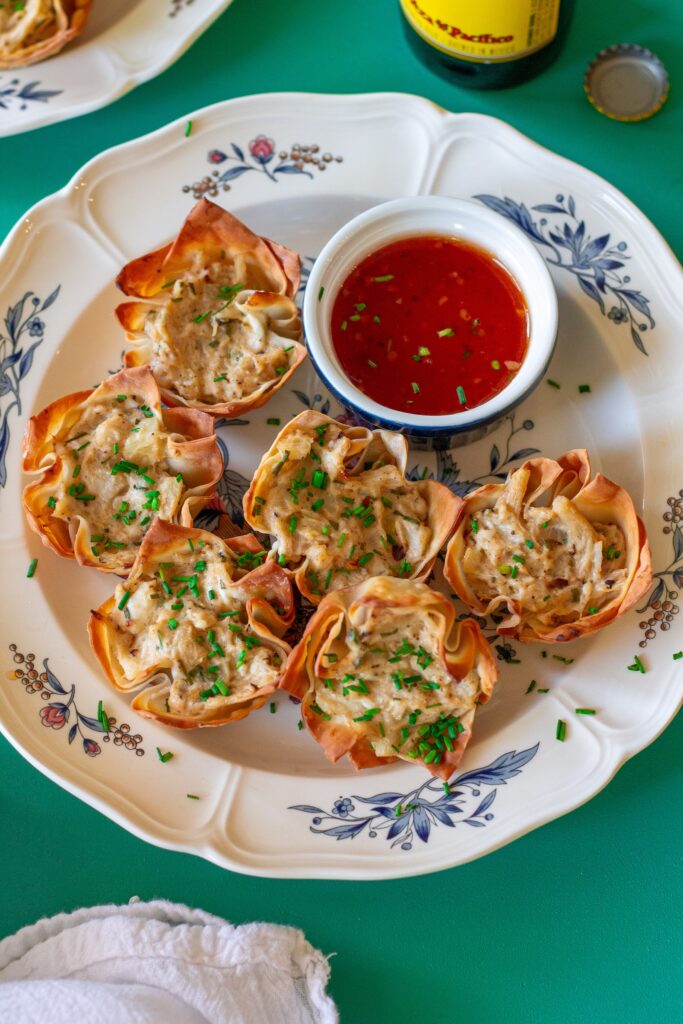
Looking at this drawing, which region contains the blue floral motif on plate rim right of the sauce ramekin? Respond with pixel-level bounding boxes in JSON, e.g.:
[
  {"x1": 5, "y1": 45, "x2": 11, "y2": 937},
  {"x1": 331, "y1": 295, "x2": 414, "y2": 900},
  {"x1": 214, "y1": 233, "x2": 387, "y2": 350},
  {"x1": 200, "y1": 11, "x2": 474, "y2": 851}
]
[{"x1": 474, "y1": 195, "x2": 654, "y2": 355}]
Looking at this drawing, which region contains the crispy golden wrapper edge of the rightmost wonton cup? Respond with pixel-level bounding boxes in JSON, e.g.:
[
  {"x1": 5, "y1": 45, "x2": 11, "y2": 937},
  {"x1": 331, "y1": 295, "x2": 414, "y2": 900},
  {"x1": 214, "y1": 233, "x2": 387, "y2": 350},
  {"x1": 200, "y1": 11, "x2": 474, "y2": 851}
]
[{"x1": 443, "y1": 449, "x2": 652, "y2": 643}]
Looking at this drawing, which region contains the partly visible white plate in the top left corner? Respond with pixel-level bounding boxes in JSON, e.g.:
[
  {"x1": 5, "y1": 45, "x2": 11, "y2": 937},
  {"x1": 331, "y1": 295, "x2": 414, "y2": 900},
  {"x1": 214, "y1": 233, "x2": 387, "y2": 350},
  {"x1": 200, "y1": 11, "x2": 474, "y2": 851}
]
[{"x1": 0, "y1": 0, "x2": 232, "y2": 137}]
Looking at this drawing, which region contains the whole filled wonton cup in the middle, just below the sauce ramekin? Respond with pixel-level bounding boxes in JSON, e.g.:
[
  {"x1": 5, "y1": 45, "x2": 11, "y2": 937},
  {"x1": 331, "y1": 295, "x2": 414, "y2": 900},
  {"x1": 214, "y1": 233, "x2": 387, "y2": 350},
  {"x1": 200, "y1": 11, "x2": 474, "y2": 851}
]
[{"x1": 244, "y1": 410, "x2": 462, "y2": 604}]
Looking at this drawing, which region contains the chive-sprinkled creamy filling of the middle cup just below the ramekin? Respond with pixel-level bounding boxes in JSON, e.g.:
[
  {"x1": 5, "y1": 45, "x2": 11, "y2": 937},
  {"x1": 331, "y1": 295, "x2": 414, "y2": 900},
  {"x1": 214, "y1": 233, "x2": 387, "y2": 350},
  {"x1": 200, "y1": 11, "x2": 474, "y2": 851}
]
[{"x1": 254, "y1": 424, "x2": 432, "y2": 594}]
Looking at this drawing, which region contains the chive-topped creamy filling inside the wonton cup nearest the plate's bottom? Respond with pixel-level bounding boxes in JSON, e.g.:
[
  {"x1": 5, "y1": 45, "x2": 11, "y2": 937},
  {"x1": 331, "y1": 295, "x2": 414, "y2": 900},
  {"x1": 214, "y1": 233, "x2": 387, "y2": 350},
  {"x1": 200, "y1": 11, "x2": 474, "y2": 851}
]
[{"x1": 312, "y1": 609, "x2": 480, "y2": 764}]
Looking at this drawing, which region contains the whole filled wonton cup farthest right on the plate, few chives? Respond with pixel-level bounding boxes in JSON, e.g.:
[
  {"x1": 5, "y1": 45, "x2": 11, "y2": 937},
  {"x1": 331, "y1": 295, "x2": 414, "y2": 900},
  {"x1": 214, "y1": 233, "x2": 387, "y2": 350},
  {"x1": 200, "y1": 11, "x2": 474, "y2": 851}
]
[{"x1": 444, "y1": 449, "x2": 652, "y2": 643}]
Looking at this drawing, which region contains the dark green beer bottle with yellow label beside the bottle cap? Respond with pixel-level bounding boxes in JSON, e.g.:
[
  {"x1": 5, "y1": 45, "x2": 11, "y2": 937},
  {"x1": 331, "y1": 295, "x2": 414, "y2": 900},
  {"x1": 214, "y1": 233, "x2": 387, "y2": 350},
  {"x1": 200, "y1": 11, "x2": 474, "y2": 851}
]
[{"x1": 399, "y1": 0, "x2": 574, "y2": 89}]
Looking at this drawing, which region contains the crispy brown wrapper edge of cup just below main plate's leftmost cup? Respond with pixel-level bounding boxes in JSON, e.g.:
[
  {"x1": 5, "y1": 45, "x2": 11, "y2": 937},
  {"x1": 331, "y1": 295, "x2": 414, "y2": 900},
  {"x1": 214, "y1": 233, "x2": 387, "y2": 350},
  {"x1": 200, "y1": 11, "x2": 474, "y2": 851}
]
[{"x1": 88, "y1": 519, "x2": 295, "y2": 729}]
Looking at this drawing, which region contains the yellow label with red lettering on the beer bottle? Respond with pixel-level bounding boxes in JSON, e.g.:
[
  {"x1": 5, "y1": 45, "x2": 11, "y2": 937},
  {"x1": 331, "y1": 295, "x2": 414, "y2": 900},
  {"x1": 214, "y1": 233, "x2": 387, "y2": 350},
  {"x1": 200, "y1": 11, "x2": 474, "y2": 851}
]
[{"x1": 400, "y1": 0, "x2": 560, "y2": 61}]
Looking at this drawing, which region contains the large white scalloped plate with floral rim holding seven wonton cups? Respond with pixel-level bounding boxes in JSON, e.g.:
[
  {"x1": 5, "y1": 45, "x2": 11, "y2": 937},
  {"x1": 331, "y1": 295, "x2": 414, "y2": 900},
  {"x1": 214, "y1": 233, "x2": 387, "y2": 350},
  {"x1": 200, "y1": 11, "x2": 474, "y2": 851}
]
[{"x1": 0, "y1": 94, "x2": 683, "y2": 879}]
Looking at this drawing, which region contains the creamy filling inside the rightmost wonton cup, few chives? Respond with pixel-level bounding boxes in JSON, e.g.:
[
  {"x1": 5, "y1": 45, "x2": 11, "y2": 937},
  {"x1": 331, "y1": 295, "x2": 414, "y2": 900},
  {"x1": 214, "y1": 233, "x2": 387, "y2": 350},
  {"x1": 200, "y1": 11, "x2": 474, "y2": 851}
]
[{"x1": 463, "y1": 493, "x2": 626, "y2": 626}]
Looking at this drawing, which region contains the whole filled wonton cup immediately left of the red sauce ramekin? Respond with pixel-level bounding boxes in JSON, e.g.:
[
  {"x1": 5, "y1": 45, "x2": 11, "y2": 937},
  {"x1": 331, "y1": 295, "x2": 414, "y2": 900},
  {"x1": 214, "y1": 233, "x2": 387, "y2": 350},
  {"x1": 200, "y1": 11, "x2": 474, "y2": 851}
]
[{"x1": 117, "y1": 199, "x2": 306, "y2": 418}]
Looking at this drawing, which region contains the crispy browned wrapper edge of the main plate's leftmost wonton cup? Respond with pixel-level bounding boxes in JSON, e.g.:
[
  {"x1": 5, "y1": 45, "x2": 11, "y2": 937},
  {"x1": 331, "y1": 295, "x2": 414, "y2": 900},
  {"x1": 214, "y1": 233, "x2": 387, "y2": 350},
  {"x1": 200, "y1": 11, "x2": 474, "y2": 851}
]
[{"x1": 22, "y1": 367, "x2": 223, "y2": 572}]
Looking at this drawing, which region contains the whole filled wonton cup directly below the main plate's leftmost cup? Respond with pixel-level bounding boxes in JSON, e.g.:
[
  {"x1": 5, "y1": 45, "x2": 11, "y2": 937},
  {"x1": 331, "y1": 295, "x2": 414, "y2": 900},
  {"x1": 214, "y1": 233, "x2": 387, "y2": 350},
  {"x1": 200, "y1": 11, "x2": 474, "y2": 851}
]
[{"x1": 88, "y1": 519, "x2": 294, "y2": 729}]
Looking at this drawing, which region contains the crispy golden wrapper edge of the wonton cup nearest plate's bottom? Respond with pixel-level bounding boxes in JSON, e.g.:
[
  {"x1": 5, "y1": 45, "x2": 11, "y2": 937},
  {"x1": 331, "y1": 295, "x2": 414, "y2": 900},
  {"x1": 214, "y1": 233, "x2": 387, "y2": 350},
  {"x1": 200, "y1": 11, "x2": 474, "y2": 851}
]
[{"x1": 279, "y1": 577, "x2": 498, "y2": 779}]
